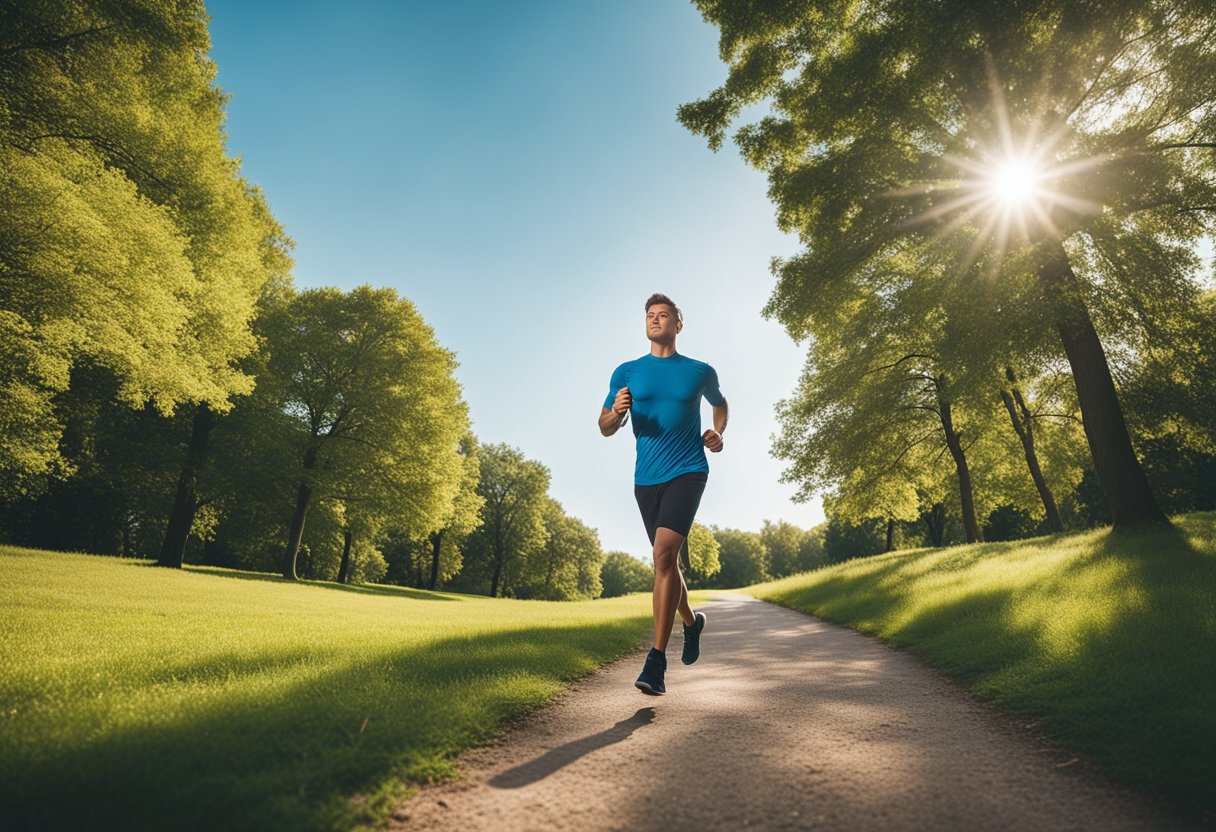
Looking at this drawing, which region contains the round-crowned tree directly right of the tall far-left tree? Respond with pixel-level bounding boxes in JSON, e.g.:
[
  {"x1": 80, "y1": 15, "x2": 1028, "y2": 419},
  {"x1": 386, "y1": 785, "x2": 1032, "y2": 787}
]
[{"x1": 266, "y1": 286, "x2": 468, "y2": 579}]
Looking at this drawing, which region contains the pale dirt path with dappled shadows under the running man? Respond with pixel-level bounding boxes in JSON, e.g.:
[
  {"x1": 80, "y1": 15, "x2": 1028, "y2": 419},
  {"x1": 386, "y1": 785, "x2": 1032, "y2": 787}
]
[{"x1": 394, "y1": 596, "x2": 1187, "y2": 832}]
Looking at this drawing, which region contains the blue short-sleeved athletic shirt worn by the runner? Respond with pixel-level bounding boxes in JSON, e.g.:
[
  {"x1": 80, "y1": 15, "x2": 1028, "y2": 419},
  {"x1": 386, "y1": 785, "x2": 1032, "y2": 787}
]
[{"x1": 604, "y1": 353, "x2": 726, "y2": 485}]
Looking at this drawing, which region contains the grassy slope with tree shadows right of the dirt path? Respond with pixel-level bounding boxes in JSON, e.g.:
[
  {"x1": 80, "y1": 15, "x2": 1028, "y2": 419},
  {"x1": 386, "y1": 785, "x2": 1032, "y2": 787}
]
[{"x1": 749, "y1": 513, "x2": 1216, "y2": 814}]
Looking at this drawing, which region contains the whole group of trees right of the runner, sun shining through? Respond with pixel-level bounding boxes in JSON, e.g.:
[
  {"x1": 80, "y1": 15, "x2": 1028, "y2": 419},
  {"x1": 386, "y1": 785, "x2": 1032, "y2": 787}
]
[{"x1": 680, "y1": 0, "x2": 1216, "y2": 542}]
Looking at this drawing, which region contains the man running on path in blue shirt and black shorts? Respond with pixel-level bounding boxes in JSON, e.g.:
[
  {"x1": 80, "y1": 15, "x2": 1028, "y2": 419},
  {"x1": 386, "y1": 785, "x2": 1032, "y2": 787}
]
[{"x1": 599, "y1": 294, "x2": 727, "y2": 696}]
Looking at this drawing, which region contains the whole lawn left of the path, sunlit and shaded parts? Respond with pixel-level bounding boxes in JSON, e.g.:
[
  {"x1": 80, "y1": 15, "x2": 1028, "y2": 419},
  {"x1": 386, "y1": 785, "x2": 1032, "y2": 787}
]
[{"x1": 0, "y1": 547, "x2": 651, "y2": 831}]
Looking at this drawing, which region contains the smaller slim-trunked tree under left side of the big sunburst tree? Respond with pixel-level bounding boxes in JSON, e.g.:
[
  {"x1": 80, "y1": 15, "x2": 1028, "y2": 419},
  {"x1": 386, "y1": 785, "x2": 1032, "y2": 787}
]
[{"x1": 773, "y1": 285, "x2": 983, "y2": 541}]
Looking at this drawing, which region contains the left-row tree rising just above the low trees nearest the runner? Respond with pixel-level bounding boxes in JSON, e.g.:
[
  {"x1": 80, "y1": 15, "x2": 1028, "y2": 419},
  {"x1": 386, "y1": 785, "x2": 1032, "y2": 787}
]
[{"x1": 461, "y1": 444, "x2": 548, "y2": 597}]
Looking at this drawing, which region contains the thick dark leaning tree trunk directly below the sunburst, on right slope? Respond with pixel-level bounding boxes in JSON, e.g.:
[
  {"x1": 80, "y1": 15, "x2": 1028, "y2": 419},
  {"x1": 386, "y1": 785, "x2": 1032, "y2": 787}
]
[{"x1": 1038, "y1": 243, "x2": 1169, "y2": 532}]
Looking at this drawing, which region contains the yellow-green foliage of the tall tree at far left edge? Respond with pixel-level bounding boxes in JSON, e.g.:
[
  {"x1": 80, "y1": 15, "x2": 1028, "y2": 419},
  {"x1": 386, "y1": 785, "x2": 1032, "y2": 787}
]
[{"x1": 0, "y1": 0, "x2": 289, "y2": 486}]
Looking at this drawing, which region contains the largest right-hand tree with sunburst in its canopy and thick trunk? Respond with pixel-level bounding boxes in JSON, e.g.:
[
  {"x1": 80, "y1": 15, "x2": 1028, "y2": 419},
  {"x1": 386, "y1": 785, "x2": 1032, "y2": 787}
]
[{"x1": 680, "y1": 0, "x2": 1216, "y2": 529}]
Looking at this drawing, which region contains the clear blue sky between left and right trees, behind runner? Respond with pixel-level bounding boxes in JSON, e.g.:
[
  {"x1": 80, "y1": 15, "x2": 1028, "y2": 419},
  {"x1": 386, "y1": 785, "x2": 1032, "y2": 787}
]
[{"x1": 208, "y1": 0, "x2": 822, "y2": 557}]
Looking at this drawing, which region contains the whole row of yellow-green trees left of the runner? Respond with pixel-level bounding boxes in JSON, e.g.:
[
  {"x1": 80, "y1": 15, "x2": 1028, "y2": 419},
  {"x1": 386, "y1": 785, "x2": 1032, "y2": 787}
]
[{"x1": 0, "y1": 0, "x2": 603, "y2": 598}]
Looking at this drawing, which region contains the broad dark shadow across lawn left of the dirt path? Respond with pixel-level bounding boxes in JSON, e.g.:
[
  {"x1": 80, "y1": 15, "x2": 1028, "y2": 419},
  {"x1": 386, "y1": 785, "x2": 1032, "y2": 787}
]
[{"x1": 0, "y1": 617, "x2": 648, "y2": 831}]
